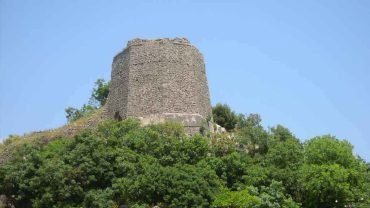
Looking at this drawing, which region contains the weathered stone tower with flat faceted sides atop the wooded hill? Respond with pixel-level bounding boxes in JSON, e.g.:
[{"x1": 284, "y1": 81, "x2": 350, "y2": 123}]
[{"x1": 108, "y1": 38, "x2": 212, "y2": 134}]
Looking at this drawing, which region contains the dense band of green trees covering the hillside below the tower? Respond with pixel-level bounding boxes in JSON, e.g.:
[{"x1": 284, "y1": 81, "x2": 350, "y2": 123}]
[{"x1": 0, "y1": 114, "x2": 370, "y2": 208}]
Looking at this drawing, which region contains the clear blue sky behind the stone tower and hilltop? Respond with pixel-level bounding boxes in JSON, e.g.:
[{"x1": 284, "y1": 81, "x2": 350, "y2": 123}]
[{"x1": 0, "y1": 0, "x2": 370, "y2": 161}]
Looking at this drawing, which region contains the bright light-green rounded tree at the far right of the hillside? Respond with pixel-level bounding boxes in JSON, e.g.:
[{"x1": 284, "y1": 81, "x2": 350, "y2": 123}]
[{"x1": 298, "y1": 135, "x2": 369, "y2": 207}]
